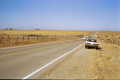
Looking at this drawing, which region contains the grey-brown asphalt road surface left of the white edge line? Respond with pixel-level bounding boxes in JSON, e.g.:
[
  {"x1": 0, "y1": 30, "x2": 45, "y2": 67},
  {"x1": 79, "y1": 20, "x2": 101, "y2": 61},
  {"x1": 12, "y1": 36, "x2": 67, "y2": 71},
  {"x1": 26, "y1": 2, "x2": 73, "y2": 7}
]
[{"x1": 0, "y1": 40, "x2": 81, "y2": 79}]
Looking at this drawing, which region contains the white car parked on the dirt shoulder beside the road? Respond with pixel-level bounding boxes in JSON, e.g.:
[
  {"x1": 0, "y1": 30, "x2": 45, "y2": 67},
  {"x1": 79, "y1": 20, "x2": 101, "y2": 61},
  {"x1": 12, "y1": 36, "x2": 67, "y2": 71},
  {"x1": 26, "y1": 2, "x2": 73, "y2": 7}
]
[{"x1": 85, "y1": 39, "x2": 99, "y2": 49}]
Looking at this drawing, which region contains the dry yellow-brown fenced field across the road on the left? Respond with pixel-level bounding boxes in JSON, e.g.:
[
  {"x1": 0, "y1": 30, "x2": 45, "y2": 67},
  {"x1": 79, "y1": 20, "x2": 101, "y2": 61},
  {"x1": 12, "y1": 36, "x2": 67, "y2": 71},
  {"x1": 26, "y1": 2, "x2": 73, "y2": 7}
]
[{"x1": 0, "y1": 30, "x2": 91, "y2": 47}]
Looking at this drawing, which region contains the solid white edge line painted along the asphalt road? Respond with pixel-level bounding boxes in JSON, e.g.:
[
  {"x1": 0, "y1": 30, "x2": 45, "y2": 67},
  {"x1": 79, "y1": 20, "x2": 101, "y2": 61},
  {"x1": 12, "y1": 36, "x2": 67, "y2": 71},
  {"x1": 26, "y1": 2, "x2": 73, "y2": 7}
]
[{"x1": 22, "y1": 44, "x2": 80, "y2": 79}]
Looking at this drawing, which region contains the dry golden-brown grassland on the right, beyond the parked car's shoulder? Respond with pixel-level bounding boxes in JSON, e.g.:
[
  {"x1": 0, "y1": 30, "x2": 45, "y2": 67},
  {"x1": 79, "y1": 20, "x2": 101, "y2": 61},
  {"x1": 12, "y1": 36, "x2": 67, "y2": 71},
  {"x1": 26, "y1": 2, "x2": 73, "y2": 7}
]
[{"x1": 94, "y1": 31, "x2": 120, "y2": 80}]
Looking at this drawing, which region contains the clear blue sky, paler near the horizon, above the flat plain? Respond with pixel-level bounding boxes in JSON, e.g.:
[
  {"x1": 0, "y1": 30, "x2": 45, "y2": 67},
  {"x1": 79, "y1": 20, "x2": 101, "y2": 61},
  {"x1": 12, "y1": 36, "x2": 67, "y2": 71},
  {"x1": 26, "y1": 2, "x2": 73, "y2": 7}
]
[{"x1": 0, "y1": 0, "x2": 120, "y2": 30}]
